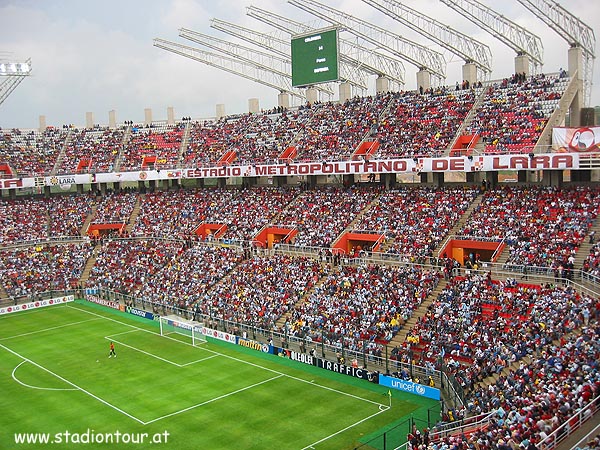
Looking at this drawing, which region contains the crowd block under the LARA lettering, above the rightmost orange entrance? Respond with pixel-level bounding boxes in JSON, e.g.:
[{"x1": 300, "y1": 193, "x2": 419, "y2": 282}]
[{"x1": 460, "y1": 186, "x2": 600, "y2": 270}]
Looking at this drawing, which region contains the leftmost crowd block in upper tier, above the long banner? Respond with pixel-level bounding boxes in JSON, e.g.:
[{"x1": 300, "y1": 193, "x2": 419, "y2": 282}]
[{"x1": 0, "y1": 127, "x2": 67, "y2": 177}]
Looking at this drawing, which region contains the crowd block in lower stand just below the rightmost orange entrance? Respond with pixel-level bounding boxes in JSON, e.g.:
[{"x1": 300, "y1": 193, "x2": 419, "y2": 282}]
[{"x1": 403, "y1": 273, "x2": 600, "y2": 392}]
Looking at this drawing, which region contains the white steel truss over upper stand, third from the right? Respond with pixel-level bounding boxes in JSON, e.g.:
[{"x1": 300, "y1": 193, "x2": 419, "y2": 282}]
[{"x1": 363, "y1": 0, "x2": 492, "y2": 79}]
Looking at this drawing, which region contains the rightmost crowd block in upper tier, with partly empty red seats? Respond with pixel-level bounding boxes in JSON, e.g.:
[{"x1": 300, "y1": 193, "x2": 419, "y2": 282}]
[{"x1": 465, "y1": 74, "x2": 568, "y2": 153}]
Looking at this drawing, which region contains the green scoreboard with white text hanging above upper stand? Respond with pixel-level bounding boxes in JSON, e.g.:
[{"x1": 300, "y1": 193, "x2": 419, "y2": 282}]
[{"x1": 292, "y1": 28, "x2": 339, "y2": 87}]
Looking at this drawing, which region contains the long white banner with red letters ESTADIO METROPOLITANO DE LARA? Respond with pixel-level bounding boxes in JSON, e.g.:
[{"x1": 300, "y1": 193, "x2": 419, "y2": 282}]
[{"x1": 0, "y1": 154, "x2": 584, "y2": 190}]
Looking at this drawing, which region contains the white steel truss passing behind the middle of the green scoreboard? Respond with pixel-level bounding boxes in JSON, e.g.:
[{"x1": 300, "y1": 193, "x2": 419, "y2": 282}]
[{"x1": 210, "y1": 19, "x2": 368, "y2": 92}]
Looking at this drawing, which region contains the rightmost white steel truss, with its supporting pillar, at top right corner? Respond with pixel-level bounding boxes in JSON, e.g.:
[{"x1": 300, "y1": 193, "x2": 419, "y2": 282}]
[{"x1": 517, "y1": 0, "x2": 596, "y2": 105}]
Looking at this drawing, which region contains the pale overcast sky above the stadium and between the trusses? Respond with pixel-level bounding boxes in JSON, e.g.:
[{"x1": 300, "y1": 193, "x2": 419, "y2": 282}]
[{"x1": 0, "y1": 0, "x2": 600, "y2": 129}]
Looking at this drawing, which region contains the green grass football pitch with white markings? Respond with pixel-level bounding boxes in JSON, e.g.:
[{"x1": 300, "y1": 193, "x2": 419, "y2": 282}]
[{"x1": 0, "y1": 302, "x2": 438, "y2": 450}]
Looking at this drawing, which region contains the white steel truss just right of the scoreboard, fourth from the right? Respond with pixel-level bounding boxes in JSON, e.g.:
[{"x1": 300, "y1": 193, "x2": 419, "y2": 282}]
[{"x1": 288, "y1": 0, "x2": 446, "y2": 84}]
